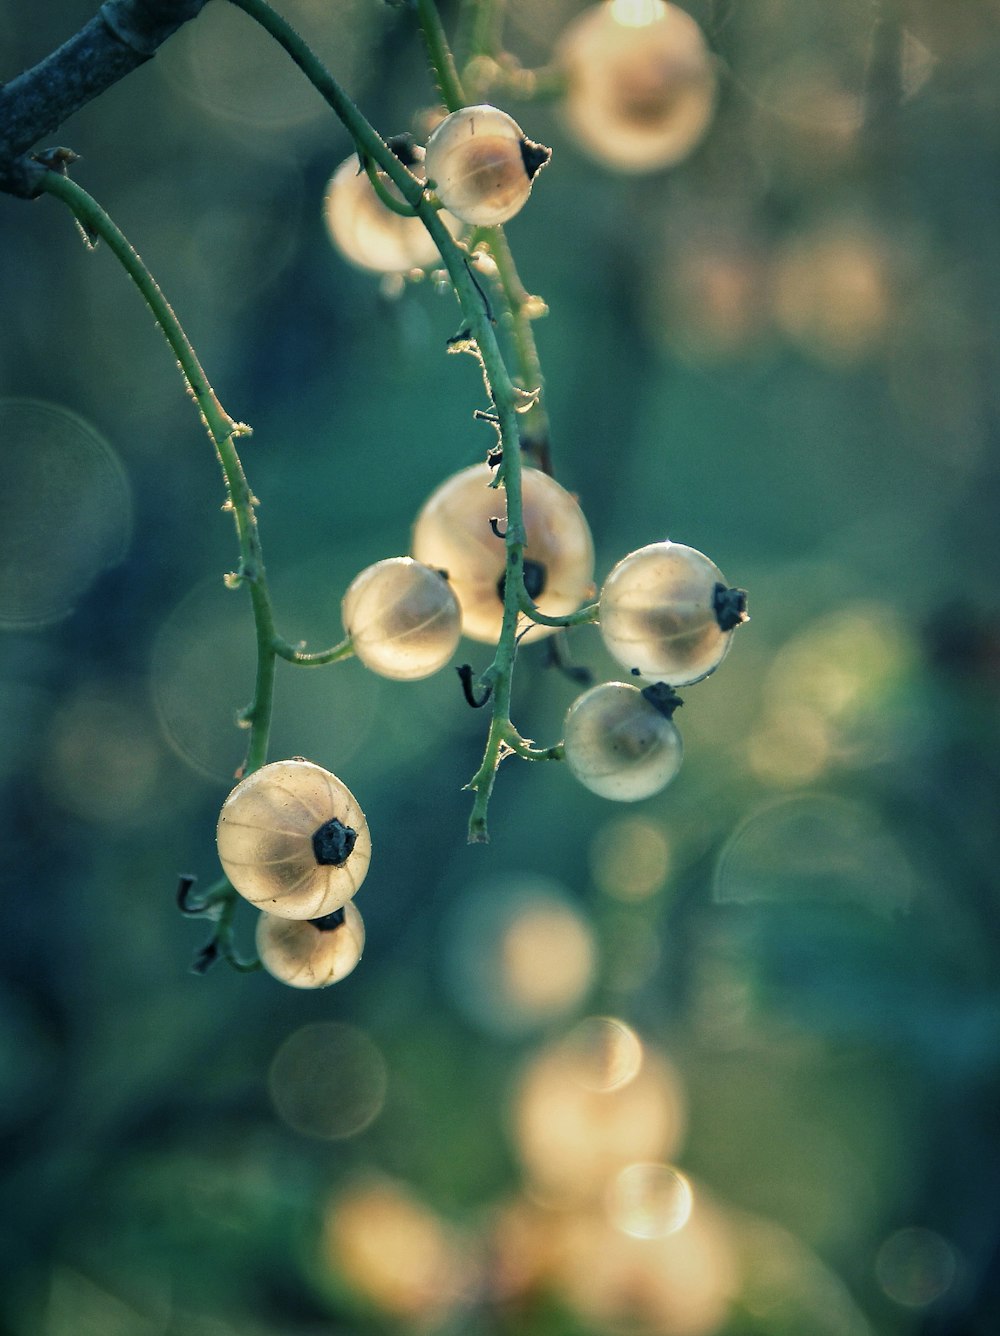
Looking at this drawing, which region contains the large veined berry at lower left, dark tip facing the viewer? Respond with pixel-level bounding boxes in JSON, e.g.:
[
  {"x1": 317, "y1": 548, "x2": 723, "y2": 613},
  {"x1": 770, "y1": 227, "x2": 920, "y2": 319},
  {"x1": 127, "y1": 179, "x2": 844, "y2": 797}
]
[{"x1": 216, "y1": 758, "x2": 371, "y2": 919}]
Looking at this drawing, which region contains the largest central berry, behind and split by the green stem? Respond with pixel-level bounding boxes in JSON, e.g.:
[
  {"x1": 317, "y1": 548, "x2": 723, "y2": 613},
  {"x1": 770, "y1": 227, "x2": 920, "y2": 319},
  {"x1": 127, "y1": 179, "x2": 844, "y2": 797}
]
[{"x1": 413, "y1": 464, "x2": 594, "y2": 644}]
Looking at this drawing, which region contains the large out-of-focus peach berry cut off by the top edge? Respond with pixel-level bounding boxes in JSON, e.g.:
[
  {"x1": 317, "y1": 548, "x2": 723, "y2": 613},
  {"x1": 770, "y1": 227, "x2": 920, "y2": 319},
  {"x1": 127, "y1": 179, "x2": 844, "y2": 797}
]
[{"x1": 557, "y1": 0, "x2": 716, "y2": 172}]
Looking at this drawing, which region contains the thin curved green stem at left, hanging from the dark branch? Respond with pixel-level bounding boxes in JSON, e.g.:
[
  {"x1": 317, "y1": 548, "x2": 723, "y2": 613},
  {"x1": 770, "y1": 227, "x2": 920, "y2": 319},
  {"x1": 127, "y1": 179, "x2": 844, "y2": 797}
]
[{"x1": 43, "y1": 171, "x2": 275, "y2": 774}]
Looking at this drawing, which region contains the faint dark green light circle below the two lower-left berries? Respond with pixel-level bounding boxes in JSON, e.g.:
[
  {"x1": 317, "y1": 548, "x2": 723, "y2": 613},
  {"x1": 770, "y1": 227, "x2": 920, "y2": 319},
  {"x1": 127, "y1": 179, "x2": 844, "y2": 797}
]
[{"x1": 267, "y1": 1022, "x2": 387, "y2": 1141}]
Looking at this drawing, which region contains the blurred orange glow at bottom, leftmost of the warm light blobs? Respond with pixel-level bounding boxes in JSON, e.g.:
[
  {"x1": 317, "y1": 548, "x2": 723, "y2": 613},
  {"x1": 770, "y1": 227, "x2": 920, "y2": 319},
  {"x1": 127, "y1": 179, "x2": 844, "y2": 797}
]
[{"x1": 322, "y1": 1178, "x2": 475, "y2": 1324}]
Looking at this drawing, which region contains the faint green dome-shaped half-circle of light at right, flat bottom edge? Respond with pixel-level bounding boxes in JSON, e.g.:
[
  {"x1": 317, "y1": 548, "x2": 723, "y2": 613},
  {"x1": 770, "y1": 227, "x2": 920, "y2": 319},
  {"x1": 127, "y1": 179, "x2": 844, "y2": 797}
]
[{"x1": 714, "y1": 794, "x2": 915, "y2": 915}]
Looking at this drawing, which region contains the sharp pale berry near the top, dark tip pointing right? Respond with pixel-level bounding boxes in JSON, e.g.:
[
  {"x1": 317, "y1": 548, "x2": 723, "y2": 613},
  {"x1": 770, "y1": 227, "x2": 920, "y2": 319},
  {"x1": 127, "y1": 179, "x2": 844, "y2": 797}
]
[{"x1": 425, "y1": 106, "x2": 550, "y2": 227}]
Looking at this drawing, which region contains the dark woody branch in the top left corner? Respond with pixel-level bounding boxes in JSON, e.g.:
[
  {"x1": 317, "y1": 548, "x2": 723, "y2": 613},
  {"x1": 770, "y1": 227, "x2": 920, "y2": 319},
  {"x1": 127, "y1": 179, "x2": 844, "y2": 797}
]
[{"x1": 0, "y1": 0, "x2": 207, "y2": 199}]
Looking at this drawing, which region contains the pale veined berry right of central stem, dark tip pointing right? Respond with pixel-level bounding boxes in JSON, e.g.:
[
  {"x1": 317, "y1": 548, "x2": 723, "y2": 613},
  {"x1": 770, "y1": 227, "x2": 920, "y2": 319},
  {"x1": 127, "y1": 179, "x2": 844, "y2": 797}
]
[{"x1": 598, "y1": 541, "x2": 746, "y2": 687}]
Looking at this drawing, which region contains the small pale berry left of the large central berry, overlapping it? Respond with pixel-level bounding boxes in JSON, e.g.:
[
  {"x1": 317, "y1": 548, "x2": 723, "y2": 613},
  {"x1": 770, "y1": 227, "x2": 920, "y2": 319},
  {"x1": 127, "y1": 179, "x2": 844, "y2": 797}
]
[{"x1": 340, "y1": 557, "x2": 462, "y2": 681}]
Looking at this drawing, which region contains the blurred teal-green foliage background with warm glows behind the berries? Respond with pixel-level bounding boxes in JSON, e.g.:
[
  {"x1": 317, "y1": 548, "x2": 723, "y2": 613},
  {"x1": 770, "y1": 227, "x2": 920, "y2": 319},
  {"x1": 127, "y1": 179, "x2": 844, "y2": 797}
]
[{"x1": 0, "y1": 0, "x2": 1000, "y2": 1336}]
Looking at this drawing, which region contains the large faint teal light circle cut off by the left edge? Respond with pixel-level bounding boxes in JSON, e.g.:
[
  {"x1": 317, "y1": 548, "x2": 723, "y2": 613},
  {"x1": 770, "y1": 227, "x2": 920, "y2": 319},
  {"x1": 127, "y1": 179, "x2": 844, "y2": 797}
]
[{"x1": 0, "y1": 399, "x2": 132, "y2": 628}]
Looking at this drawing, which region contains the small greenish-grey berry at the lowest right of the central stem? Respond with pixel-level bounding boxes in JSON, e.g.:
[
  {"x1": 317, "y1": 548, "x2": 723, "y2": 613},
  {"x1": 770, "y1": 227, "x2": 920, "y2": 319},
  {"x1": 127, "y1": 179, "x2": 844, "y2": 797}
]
[{"x1": 565, "y1": 681, "x2": 684, "y2": 803}]
